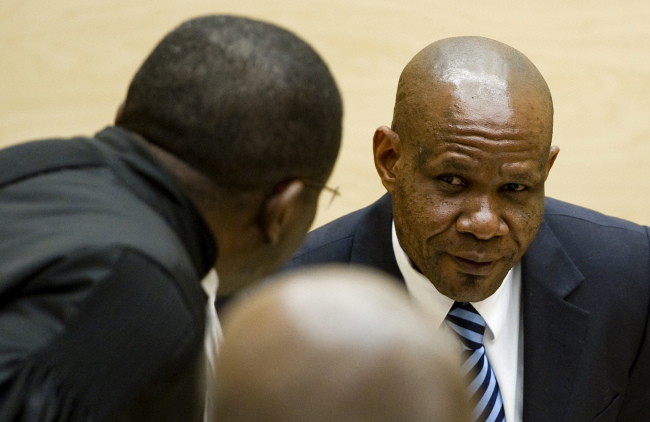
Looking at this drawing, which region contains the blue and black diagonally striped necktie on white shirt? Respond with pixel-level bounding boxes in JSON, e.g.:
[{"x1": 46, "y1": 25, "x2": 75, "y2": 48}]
[{"x1": 446, "y1": 302, "x2": 506, "y2": 422}]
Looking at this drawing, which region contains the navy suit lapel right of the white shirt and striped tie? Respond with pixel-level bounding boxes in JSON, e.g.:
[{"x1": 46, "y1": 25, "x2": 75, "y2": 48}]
[{"x1": 522, "y1": 222, "x2": 590, "y2": 422}]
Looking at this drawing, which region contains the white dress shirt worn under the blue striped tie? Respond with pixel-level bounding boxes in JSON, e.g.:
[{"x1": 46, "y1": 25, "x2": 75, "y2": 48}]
[{"x1": 393, "y1": 223, "x2": 524, "y2": 422}]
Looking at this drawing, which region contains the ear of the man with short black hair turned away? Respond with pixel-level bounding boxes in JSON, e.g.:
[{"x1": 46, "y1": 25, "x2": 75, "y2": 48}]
[{"x1": 260, "y1": 180, "x2": 305, "y2": 245}]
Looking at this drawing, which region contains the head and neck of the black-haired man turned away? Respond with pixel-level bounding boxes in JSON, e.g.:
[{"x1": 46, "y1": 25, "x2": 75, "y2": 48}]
[{"x1": 116, "y1": 16, "x2": 342, "y2": 290}]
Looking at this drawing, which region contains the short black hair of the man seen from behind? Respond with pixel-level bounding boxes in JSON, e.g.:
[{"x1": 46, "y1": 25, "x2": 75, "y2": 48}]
[{"x1": 117, "y1": 15, "x2": 343, "y2": 191}]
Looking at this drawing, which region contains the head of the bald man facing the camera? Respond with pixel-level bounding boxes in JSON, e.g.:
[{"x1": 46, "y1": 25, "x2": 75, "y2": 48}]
[{"x1": 374, "y1": 37, "x2": 559, "y2": 302}]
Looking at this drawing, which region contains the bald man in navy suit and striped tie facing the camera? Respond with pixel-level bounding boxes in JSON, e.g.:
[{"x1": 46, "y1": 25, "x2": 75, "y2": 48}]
[{"x1": 287, "y1": 37, "x2": 650, "y2": 422}]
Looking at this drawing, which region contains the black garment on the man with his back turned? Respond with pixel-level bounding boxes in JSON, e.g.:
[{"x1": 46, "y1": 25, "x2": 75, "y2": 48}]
[{"x1": 0, "y1": 127, "x2": 216, "y2": 421}]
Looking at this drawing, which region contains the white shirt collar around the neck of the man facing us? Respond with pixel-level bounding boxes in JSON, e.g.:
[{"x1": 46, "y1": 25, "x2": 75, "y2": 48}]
[{"x1": 392, "y1": 221, "x2": 521, "y2": 340}]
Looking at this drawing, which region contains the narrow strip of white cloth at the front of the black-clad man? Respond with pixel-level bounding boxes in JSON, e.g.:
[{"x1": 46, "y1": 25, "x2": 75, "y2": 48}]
[{"x1": 201, "y1": 269, "x2": 223, "y2": 422}]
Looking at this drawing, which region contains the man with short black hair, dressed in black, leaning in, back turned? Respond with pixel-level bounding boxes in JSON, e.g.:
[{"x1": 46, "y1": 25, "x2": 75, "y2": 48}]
[{"x1": 0, "y1": 16, "x2": 342, "y2": 421}]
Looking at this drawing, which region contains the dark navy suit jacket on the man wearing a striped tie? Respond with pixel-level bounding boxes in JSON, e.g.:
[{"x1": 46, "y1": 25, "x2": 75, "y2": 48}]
[{"x1": 285, "y1": 195, "x2": 650, "y2": 422}]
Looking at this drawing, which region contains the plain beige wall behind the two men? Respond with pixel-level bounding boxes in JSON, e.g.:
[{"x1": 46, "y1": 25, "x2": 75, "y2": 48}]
[{"x1": 0, "y1": 0, "x2": 650, "y2": 225}]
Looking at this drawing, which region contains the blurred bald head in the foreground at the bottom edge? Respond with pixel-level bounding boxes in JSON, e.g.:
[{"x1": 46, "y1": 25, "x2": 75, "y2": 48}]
[{"x1": 217, "y1": 266, "x2": 468, "y2": 422}]
